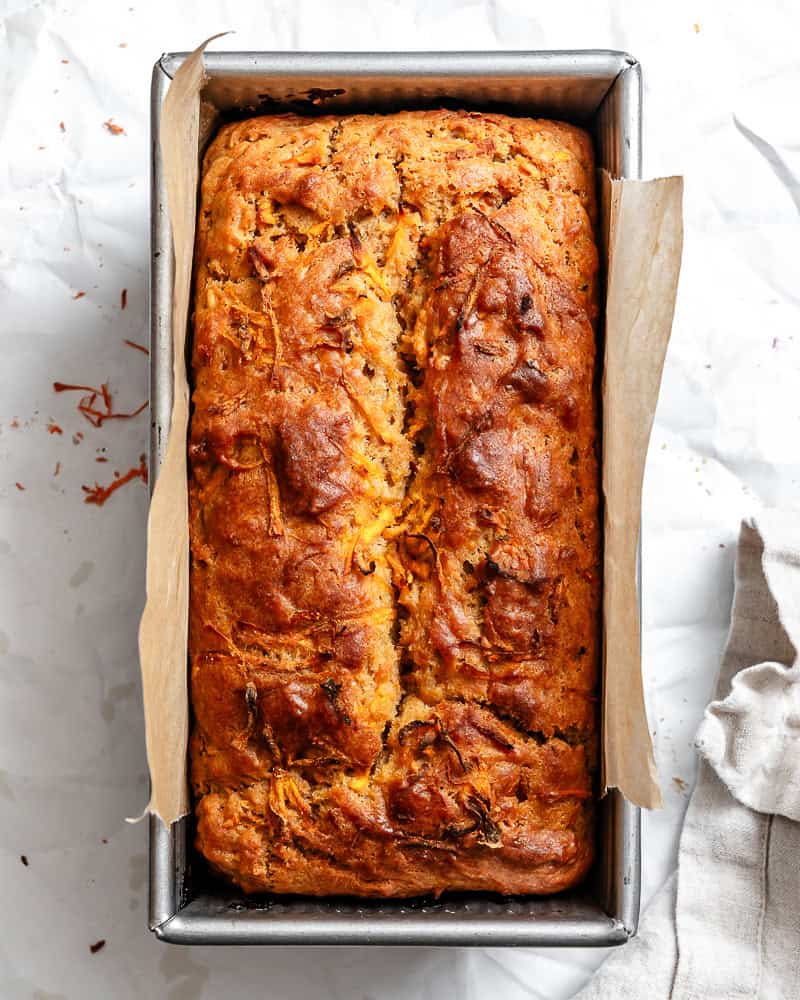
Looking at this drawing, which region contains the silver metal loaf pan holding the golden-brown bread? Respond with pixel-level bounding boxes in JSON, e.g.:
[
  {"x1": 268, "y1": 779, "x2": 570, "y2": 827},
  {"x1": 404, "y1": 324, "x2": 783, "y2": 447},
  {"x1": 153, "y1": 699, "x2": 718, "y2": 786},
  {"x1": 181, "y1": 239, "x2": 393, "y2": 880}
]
[{"x1": 149, "y1": 51, "x2": 641, "y2": 947}]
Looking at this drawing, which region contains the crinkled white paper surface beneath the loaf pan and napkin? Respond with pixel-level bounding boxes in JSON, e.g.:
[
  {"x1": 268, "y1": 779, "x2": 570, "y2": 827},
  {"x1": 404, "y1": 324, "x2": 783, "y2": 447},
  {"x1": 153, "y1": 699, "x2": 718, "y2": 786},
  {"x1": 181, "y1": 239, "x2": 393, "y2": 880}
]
[{"x1": 0, "y1": 0, "x2": 800, "y2": 1000}]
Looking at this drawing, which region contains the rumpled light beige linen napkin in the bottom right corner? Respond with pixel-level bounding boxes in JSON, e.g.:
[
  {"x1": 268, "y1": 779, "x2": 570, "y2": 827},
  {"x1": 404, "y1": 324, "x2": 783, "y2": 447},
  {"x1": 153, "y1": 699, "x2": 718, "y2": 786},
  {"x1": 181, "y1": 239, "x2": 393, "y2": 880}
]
[{"x1": 576, "y1": 511, "x2": 800, "y2": 1000}]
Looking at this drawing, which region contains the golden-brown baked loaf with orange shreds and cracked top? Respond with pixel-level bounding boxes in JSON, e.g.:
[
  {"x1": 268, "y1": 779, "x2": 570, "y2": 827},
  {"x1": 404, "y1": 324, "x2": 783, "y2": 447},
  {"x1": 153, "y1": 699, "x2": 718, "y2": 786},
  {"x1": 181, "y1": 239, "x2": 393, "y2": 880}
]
[{"x1": 189, "y1": 111, "x2": 600, "y2": 896}]
